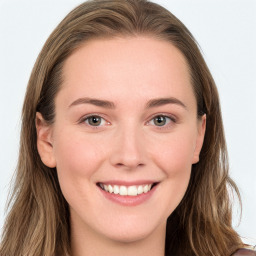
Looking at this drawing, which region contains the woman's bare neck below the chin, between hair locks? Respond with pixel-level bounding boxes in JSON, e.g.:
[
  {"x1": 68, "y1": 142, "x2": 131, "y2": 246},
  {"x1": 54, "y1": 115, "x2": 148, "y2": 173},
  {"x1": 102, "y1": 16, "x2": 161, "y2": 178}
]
[{"x1": 71, "y1": 217, "x2": 166, "y2": 256}]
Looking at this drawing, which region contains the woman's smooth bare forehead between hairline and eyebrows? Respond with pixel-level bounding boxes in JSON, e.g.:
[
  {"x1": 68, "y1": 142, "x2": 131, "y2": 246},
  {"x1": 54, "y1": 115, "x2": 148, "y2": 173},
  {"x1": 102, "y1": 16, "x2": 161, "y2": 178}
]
[{"x1": 59, "y1": 36, "x2": 193, "y2": 107}]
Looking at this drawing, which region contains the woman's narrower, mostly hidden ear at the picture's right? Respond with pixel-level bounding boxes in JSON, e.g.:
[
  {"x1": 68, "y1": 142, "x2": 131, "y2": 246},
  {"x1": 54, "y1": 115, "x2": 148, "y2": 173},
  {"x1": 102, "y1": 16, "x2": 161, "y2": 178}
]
[{"x1": 192, "y1": 114, "x2": 206, "y2": 164}]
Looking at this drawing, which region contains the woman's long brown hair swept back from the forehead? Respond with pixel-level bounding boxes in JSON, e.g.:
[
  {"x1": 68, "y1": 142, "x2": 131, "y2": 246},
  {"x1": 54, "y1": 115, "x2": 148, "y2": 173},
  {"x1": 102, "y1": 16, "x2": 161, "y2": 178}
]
[{"x1": 0, "y1": 0, "x2": 242, "y2": 256}]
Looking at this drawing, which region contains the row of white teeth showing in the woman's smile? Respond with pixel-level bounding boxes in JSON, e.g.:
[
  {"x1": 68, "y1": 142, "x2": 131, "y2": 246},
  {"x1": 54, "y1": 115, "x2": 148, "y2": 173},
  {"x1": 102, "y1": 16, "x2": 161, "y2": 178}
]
[{"x1": 99, "y1": 183, "x2": 153, "y2": 196}]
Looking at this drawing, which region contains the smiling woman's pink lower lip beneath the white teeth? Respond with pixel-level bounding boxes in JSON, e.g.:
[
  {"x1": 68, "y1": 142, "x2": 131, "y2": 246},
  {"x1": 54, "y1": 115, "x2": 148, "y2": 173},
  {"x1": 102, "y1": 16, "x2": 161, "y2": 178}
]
[{"x1": 99, "y1": 185, "x2": 157, "y2": 206}]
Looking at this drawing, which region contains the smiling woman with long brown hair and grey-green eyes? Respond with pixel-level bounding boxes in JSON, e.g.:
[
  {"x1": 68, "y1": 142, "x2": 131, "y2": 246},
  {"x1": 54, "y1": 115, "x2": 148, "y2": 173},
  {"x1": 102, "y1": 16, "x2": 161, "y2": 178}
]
[{"x1": 0, "y1": 0, "x2": 255, "y2": 256}]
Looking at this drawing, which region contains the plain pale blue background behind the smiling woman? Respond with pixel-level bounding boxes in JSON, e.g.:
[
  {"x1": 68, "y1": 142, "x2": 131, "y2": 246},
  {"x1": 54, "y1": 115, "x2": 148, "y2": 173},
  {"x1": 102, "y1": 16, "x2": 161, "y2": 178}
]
[{"x1": 0, "y1": 0, "x2": 256, "y2": 244}]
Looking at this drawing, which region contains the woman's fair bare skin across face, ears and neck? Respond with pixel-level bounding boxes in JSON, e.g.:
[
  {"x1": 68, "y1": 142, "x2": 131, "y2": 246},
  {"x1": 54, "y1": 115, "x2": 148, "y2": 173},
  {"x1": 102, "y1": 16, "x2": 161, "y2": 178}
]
[{"x1": 36, "y1": 36, "x2": 206, "y2": 256}]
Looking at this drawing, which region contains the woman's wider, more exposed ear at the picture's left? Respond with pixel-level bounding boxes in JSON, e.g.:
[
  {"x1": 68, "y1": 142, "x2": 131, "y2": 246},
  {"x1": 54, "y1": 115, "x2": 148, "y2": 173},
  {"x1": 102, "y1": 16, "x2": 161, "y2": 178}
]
[{"x1": 35, "y1": 112, "x2": 56, "y2": 168}]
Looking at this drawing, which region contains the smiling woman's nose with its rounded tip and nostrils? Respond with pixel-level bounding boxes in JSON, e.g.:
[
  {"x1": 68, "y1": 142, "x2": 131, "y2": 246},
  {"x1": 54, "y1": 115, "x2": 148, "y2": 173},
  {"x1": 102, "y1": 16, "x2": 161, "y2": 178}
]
[{"x1": 110, "y1": 124, "x2": 146, "y2": 170}]
